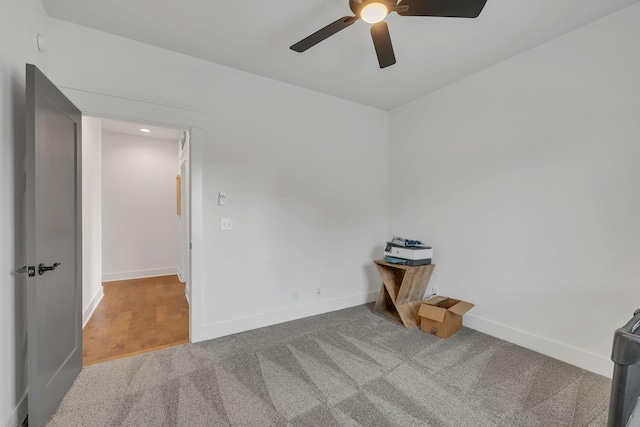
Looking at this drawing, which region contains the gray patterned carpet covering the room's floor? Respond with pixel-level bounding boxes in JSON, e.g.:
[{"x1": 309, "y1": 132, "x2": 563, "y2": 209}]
[{"x1": 48, "y1": 305, "x2": 611, "y2": 427}]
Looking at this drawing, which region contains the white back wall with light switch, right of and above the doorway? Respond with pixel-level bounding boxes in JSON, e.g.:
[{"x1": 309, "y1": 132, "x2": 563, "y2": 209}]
[{"x1": 50, "y1": 19, "x2": 388, "y2": 341}]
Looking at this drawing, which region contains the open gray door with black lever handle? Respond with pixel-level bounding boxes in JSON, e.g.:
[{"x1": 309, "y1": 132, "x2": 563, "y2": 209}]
[{"x1": 26, "y1": 64, "x2": 82, "y2": 427}]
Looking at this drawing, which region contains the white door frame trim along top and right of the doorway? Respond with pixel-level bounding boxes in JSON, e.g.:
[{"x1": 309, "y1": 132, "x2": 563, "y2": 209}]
[{"x1": 59, "y1": 86, "x2": 205, "y2": 342}]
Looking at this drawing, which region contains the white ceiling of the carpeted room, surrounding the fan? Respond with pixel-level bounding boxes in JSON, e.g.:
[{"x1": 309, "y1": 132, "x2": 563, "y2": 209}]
[{"x1": 42, "y1": 0, "x2": 640, "y2": 110}]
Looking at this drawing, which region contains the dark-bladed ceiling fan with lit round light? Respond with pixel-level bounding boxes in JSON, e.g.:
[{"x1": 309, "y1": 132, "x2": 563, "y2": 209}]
[{"x1": 290, "y1": 0, "x2": 487, "y2": 68}]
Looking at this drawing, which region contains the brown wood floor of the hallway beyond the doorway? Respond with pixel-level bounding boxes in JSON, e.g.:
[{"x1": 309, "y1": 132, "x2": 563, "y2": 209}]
[{"x1": 82, "y1": 275, "x2": 189, "y2": 366}]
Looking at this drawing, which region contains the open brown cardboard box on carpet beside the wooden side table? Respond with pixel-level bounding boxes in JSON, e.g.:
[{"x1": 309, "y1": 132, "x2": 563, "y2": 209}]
[{"x1": 418, "y1": 296, "x2": 474, "y2": 338}]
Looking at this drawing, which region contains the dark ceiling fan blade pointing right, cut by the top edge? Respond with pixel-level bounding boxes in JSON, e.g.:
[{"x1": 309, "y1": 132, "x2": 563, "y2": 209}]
[{"x1": 398, "y1": 0, "x2": 487, "y2": 18}]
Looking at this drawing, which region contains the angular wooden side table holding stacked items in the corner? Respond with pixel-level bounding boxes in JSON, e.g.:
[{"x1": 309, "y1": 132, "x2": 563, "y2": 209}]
[{"x1": 373, "y1": 259, "x2": 435, "y2": 328}]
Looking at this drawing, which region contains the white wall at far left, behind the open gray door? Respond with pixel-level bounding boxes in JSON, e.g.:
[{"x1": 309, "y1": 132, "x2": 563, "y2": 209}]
[{"x1": 0, "y1": 0, "x2": 48, "y2": 427}]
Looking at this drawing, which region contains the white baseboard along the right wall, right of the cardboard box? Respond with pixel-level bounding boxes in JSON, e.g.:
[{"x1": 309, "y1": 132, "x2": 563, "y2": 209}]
[{"x1": 463, "y1": 314, "x2": 613, "y2": 378}]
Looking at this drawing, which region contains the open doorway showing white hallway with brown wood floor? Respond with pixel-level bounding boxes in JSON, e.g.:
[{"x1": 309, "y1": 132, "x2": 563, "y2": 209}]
[{"x1": 82, "y1": 116, "x2": 190, "y2": 365}]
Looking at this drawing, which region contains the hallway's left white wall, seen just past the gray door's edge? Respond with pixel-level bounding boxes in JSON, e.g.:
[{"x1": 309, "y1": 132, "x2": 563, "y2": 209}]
[{"x1": 82, "y1": 116, "x2": 104, "y2": 326}]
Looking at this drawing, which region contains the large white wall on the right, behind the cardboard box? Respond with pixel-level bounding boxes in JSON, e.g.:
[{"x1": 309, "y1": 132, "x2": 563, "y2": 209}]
[{"x1": 389, "y1": 5, "x2": 640, "y2": 375}]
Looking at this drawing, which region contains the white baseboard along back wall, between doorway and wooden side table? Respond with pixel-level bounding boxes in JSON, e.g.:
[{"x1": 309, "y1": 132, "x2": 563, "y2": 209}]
[{"x1": 191, "y1": 291, "x2": 379, "y2": 342}]
